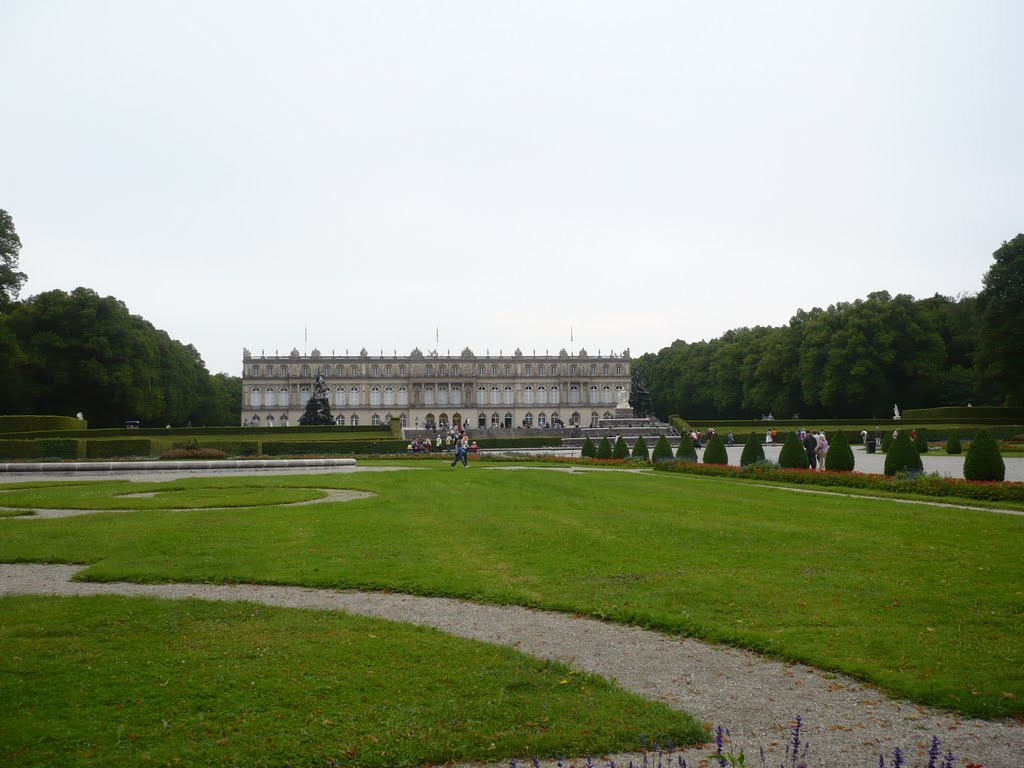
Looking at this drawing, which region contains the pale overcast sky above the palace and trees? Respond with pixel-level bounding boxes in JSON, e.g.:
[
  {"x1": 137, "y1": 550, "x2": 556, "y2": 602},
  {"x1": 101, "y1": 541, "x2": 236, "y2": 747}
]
[{"x1": 0, "y1": 0, "x2": 1024, "y2": 375}]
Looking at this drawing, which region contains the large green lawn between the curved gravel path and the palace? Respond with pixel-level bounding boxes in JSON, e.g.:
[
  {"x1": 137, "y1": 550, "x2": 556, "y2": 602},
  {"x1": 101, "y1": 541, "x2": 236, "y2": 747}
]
[{"x1": 0, "y1": 468, "x2": 1024, "y2": 717}]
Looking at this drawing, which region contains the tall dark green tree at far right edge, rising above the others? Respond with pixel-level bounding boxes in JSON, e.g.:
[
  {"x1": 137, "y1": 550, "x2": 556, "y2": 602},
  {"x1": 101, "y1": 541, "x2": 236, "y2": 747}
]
[{"x1": 977, "y1": 234, "x2": 1024, "y2": 406}]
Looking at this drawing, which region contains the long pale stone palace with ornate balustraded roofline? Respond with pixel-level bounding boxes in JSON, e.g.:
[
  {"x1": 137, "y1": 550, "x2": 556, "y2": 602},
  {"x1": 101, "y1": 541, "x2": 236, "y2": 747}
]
[{"x1": 242, "y1": 348, "x2": 631, "y2": 429}]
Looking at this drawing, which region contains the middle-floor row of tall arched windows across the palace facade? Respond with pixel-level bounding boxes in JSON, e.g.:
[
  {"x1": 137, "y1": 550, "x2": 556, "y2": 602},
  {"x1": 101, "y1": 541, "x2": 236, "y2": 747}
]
[{"x1": 249, "y1": 384, "x2": 623, "y2": 408}]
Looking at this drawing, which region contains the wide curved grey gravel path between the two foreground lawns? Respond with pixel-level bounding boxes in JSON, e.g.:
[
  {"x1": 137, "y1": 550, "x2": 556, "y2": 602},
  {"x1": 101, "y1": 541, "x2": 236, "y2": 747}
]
[{"x1": 0, "y1": 564, "x2": 1024, "y2": 768}]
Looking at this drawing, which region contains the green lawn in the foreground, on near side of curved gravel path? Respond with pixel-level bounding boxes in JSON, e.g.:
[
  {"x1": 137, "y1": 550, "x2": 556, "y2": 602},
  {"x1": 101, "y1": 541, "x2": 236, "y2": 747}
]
[{"x1": 0, "y1": 596, "x2": 707, "y2": 768}]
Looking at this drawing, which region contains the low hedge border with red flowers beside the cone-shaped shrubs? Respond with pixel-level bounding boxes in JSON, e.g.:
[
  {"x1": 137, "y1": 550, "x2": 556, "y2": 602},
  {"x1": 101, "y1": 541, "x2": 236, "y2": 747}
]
[{"x1": 654, "y1": 462, "x2": 1024, "y2": 504}]
